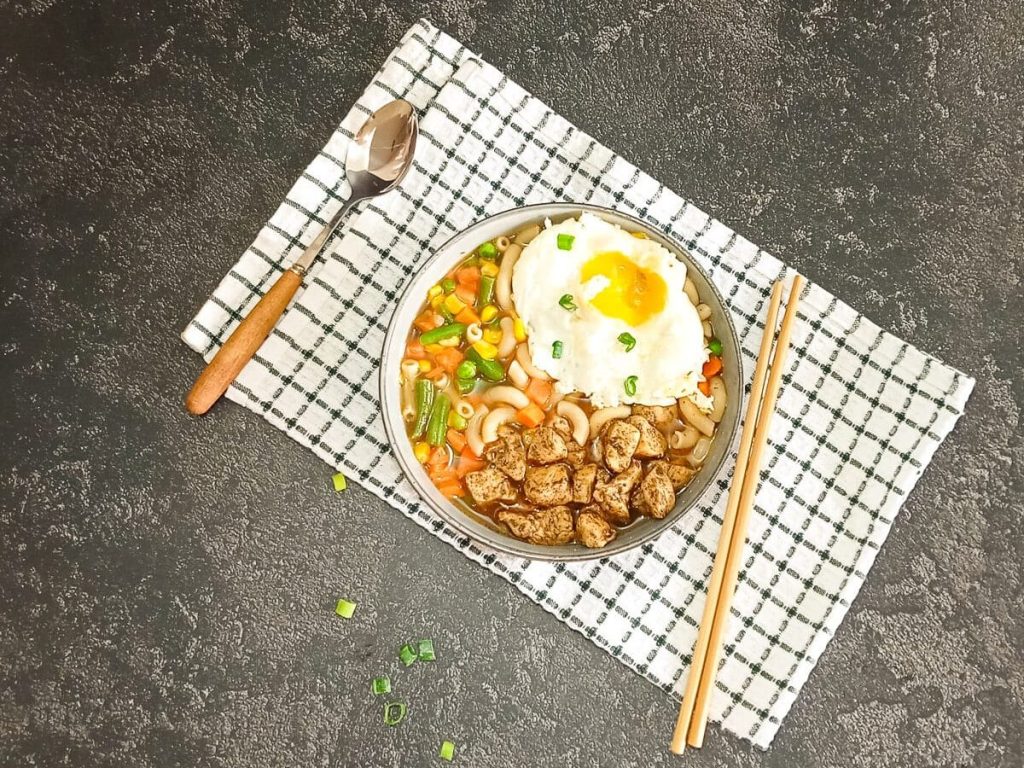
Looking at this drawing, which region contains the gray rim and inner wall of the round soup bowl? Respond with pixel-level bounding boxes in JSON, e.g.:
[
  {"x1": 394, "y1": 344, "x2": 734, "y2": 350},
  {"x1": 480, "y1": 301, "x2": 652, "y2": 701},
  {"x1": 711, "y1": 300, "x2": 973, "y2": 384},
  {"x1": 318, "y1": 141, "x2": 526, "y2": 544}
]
[{"x1": 379, "y1": 203, "x2": 745, "y2": 562}]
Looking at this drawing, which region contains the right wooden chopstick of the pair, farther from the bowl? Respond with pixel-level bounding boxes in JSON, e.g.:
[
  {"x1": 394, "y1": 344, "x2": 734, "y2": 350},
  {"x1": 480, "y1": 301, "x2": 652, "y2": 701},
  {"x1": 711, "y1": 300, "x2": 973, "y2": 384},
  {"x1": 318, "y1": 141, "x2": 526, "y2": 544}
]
[{"x1": 686, "y1": 274, "x2": 804, "y2": 748}]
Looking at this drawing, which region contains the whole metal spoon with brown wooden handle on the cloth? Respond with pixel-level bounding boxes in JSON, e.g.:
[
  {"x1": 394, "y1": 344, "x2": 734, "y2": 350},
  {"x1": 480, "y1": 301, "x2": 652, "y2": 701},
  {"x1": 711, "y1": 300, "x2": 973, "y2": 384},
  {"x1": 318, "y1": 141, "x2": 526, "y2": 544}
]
[{"x1": 185, "y1": 99, "x2": 418, "y2": 416}]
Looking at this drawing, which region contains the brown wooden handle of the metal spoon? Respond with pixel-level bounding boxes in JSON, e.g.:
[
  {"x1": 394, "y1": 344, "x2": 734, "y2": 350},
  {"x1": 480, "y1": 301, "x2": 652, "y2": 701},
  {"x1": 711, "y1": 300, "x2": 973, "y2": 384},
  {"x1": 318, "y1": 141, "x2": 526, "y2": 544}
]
[{"x1": 185, "y1": 269, "x2": 302, "y2": 416}]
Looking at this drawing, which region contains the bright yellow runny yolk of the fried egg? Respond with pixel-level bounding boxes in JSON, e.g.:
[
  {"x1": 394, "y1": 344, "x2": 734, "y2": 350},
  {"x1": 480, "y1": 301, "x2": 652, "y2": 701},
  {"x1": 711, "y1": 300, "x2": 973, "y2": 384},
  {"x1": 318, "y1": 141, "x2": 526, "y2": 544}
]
[{"x1": 580, "y1": 251, "x2": 668, "y2": 326}]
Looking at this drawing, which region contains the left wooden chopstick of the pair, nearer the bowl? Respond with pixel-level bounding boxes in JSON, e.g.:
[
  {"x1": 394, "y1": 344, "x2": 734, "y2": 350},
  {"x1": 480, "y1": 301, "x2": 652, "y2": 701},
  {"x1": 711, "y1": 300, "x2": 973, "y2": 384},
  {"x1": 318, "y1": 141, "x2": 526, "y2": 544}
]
[{"x1": 670, "y1": 281, "x2": 782, "y2": 755}]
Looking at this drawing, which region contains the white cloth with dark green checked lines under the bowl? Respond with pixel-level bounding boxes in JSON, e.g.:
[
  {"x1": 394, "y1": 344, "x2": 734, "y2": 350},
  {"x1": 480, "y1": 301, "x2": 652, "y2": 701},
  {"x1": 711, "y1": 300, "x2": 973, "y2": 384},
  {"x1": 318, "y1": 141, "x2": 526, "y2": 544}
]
[{"x1": 183, "y1": 22, "x2": 974, "y2": 748}]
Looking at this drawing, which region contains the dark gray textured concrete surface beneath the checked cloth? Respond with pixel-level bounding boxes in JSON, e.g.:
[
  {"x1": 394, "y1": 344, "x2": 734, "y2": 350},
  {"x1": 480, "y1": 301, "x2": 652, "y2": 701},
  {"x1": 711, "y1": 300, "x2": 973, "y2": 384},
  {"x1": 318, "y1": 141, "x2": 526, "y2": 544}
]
[{"x1": 0, "y1": 0, "x2": 1024, "y2": 768}]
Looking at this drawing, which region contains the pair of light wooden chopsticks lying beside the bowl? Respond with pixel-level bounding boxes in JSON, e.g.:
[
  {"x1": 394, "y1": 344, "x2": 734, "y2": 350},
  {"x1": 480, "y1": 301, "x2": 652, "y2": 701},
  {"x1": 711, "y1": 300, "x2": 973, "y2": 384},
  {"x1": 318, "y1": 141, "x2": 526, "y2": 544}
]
[{"x1": 671, "y1": 274, "x2": 804, "y2": 755}]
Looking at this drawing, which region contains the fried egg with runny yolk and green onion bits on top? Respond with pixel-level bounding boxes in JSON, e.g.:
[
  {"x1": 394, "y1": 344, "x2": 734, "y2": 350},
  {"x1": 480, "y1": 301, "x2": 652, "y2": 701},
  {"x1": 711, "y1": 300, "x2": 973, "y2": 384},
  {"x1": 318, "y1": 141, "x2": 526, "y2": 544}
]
[{"x1": 512, "y1": 213, "x2": 708, "y2": 408}]
